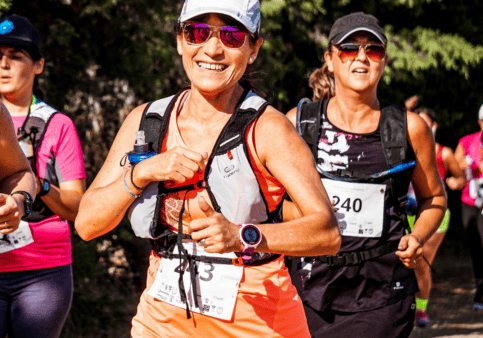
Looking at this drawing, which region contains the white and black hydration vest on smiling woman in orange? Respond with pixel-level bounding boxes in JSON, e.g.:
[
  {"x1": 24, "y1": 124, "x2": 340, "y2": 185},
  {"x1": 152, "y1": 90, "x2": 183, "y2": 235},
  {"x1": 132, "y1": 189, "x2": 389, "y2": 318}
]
[{"x1": 128, "y1": 90, "x2": 283, "y2": 265}]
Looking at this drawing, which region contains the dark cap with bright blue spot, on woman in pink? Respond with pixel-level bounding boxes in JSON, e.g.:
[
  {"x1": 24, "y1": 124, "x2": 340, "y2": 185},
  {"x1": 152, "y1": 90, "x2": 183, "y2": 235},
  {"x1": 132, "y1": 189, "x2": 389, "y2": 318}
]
[{"x1": 0, "y1": 14, "x2": 40, "y2": 49}]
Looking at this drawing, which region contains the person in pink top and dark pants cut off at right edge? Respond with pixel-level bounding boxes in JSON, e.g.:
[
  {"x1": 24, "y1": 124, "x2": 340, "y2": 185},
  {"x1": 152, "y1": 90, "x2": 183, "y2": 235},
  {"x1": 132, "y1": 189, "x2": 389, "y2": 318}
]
[{"x1": 455, "y1": 105, "x2": 483, "y2": 311}]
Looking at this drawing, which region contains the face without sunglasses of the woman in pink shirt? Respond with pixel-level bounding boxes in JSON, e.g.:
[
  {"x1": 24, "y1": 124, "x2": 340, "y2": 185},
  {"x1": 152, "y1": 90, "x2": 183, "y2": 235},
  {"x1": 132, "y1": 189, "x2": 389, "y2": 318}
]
[{"x1": 0, "y1": 45, "x2": 44, "y2": 96}]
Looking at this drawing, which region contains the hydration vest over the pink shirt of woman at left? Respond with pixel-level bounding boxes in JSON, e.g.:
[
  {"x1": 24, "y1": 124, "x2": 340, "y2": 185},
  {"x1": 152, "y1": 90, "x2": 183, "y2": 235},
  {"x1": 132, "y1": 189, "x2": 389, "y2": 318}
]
[{"x1": 22, "y1": 98, "x2": 59, "y2": 222}]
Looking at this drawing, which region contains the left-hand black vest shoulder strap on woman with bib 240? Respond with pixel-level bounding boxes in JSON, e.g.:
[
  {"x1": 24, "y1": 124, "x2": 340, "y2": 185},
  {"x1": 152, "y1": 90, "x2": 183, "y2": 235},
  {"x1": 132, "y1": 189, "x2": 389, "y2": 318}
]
[{"x1": 296, "y1": 98, "x2": 324, "y2": 158}]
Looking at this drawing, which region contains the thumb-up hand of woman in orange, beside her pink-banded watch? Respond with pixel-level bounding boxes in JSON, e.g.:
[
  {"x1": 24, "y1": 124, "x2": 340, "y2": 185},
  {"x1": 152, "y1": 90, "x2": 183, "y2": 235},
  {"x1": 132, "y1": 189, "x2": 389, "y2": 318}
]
[{"x1": 190, "y1": 197, "x2": 244, "y2": 253}]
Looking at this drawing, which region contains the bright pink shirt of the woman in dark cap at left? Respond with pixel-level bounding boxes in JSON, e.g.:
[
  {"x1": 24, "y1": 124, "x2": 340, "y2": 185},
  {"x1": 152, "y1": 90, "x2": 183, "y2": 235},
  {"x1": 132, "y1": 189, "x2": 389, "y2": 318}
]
[{"x1": 0, "y1": 114, "x2": 86, "y2": 272}]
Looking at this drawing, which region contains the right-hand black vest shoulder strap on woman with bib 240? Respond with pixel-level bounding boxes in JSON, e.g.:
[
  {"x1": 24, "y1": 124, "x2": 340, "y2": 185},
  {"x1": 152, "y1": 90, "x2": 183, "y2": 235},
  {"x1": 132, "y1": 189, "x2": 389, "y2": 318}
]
[{"x1": 380, "y1": 102, "x2": 408, "y2": 168}]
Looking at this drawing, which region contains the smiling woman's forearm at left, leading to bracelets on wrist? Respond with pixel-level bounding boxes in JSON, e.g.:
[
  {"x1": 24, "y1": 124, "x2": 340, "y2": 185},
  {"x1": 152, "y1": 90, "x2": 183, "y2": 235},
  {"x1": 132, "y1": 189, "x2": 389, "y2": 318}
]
[{"x1": 75, "y1": 172, "x2": 141, "y2": 240}]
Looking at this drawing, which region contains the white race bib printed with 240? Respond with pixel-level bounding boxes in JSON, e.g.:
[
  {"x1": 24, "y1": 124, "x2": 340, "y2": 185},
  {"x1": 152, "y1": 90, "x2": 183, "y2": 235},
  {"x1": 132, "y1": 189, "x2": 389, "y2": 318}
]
[{"x1": 322, "y1": 178, "x2": 386, "y2": 238}]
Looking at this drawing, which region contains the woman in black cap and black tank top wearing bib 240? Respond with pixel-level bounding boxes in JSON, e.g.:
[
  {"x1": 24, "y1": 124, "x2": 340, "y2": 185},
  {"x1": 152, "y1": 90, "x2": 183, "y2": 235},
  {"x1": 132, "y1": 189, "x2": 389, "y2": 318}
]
[{"x1": 286, "y1": 12, "x2": 446, "y2": 338}]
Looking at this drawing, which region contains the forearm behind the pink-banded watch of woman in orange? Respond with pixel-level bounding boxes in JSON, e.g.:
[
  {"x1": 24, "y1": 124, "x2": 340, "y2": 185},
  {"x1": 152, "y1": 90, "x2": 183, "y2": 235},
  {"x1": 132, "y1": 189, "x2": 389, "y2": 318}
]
[{"x1": 257, "y1": 211, "x2": 341, "y2": 256}]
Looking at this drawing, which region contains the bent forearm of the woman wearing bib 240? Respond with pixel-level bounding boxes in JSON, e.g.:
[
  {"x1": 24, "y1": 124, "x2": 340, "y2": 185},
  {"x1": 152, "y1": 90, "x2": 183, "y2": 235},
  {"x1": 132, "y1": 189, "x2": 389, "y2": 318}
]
[{"x1": 412, "y1": 196, "x2": 446, "y2": 246}]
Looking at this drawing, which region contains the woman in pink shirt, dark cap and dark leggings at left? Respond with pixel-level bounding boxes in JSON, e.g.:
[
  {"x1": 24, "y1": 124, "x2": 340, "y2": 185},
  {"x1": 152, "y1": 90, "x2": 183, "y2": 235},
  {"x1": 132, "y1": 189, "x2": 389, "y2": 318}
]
[{"x1": 0, "y1": 15, "x2": 85, "y2": 338}]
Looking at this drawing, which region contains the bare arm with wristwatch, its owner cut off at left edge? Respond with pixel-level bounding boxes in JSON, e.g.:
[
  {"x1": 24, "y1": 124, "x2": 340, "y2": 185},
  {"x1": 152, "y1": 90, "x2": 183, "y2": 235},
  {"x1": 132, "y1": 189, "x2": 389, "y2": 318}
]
[{"x1": 0, "y1": 104, "x2": 36, "y2": 234}]
